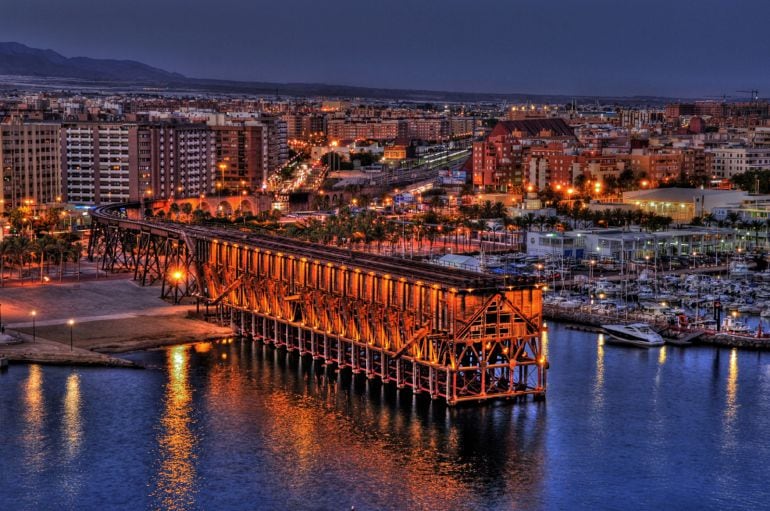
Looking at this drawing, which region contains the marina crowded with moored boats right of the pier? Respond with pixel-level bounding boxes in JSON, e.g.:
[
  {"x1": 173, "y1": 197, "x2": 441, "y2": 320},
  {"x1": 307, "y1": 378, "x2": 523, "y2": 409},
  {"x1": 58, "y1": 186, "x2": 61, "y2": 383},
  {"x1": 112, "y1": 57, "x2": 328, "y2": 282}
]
[{"x1": 520, "y1": 253, "x2": 770, "y2": 349}]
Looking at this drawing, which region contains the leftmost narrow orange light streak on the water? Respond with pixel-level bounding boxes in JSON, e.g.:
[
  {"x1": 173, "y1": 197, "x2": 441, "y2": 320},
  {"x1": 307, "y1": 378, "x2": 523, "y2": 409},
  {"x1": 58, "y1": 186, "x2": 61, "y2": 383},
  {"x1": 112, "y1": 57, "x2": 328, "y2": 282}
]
[{"x1": 22, "y1": 365, "x2": 47, "y2": 472}]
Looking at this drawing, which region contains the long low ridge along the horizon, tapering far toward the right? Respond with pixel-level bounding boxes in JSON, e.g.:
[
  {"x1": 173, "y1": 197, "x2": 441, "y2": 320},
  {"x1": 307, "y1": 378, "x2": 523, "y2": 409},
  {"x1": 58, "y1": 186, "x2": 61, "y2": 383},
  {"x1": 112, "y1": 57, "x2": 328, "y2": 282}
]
[{"x1": 0, "y1": 43, "x2": 671, "y2": 105}]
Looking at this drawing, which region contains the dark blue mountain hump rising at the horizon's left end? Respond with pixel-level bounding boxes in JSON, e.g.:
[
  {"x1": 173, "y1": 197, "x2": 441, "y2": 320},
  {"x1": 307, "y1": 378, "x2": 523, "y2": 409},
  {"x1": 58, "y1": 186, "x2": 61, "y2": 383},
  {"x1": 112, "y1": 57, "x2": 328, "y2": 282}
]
[{"x1": 0, "y1": 43, "x2": 185, "y2": 83}]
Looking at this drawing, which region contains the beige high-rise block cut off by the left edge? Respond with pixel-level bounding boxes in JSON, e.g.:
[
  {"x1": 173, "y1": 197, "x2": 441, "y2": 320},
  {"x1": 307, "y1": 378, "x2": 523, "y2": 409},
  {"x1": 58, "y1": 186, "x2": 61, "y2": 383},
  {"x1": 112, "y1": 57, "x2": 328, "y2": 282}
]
[{"x1": 0, "y1": 121, "x2": 62, "y2": 212}]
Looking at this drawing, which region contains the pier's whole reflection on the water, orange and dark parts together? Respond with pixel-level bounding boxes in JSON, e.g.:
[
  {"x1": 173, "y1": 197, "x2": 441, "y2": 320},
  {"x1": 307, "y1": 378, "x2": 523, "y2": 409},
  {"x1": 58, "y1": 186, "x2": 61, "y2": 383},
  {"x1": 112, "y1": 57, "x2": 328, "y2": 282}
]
[{"x1": 198, "y1": 343, "x2": 543, "y2": 509}]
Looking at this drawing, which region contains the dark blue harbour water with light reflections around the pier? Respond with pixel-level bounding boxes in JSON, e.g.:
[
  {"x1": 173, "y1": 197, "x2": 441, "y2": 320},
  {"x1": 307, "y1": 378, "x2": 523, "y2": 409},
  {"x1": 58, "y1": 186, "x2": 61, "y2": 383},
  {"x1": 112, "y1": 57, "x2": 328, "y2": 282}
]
[{"x1": 0, "y1": 325, "x2": 770, "y2": 510}]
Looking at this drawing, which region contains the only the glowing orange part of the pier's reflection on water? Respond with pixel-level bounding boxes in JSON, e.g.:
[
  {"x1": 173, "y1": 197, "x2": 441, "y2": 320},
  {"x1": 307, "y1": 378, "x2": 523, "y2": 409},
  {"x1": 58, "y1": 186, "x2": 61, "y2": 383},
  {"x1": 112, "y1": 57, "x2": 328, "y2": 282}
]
[{"x1": 206, "y1": 346, "x2": 480, "y2": 509}]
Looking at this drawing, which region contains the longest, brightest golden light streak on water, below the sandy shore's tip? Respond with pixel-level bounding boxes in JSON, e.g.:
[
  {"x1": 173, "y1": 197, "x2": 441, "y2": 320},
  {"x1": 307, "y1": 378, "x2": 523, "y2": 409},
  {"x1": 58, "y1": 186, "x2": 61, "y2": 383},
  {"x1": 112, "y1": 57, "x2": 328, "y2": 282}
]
[{"x1": 152, "y1": 346, "x2": 196, "y2": 510}]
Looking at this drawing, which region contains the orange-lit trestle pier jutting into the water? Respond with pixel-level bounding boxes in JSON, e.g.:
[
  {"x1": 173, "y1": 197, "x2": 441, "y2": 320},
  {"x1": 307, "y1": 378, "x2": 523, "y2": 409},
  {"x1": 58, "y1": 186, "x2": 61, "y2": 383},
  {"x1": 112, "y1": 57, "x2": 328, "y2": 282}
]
[{"x1": 88, "y1": 204, "x2": 548, "y2": 406}]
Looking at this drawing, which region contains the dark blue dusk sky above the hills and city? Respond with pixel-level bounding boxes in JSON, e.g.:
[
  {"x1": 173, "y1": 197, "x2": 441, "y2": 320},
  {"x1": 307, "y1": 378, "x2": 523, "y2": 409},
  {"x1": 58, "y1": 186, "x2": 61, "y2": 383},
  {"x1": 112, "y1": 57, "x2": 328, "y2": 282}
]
[{"x1": 6, "y1": 0, "x2": 770, "y2": 96}]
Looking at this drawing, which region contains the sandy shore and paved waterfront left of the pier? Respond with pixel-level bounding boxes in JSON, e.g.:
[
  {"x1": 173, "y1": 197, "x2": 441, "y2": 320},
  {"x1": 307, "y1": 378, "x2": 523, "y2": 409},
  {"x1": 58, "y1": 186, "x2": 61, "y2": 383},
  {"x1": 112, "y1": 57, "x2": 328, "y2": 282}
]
[{"x1": 0, "y1": 278, "x2": 232, "y2": 367}]
